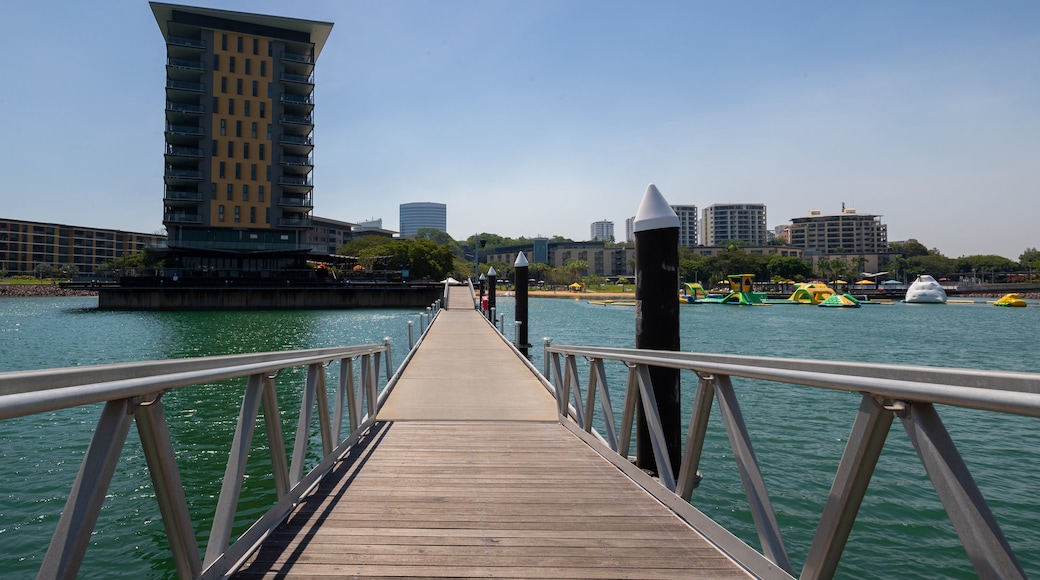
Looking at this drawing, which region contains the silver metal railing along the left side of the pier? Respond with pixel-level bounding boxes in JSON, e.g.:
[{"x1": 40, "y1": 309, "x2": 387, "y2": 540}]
[{"x1": 0, "y1": 301, "x2": 440, "y2": 578}]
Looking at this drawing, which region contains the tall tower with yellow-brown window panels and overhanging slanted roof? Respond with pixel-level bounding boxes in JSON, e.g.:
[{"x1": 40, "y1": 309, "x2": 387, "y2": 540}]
[{"x1": 150, "y1": 2, "x2": 333, "y2": 270}]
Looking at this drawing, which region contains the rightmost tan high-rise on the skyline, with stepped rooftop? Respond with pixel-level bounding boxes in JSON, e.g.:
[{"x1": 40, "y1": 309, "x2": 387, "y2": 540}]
[{"x1": 787, "y1": 207, "x2": 888, "y2": 254}]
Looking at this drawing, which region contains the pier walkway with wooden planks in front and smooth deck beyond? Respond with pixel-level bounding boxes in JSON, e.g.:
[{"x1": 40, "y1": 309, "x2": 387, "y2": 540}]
[{"x1": 229, "y1": 288, "x2": 757, "y2": 578}]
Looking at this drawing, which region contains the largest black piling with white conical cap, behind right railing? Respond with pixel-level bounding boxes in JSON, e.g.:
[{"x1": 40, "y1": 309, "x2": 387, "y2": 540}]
[{"x1": 633, "y1": 183, "x2": 682, "y2": 474}]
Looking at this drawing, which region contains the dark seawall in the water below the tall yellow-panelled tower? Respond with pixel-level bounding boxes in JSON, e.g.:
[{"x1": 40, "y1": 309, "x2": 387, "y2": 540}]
[{"x1": 98, "y1": 284, "x2": 443, "y2": 310}]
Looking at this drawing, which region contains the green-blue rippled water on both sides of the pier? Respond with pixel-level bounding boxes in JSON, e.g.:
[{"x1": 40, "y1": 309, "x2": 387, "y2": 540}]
[{"x1": 0, "y1": 297, "x2": 1040, "y2": 578}]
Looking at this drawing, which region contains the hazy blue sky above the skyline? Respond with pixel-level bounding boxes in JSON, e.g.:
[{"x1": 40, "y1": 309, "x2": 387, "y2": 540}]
[{"x1": 0, "y1": 0, "x2": 1040, "y2": 260}]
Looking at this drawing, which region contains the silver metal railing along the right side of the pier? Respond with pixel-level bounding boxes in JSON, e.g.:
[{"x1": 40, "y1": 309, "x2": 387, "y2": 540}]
[{"x1": 543, "y1": 347, "x2": 1040, "y2": 578}]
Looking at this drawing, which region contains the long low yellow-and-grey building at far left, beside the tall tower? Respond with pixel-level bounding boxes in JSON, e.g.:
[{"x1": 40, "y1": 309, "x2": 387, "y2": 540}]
[{"x1": 0, "y1": 217, "x2": 166, "y2": 276}]
